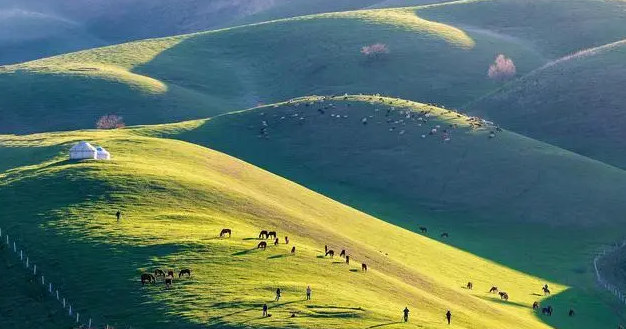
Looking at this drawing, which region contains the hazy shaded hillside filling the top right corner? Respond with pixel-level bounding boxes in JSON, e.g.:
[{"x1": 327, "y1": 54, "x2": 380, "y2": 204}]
[{"x1": 420, "y1": 0, "x2": 626, "y2": 58}]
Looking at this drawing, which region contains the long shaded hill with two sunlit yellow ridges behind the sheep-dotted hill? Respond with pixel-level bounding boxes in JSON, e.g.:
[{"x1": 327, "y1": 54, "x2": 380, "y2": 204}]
[{"x1": 0, "y1": 8, "x2": 543, "y2": 133}]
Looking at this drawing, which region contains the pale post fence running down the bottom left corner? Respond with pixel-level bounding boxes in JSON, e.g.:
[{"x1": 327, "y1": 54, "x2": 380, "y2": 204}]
[{"x1": 0, "y1": 228, "x2": 124, "y2": 329}]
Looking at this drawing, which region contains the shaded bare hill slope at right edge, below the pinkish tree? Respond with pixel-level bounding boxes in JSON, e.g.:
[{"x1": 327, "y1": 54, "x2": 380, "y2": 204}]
[{"x1": 469, "y1": 41, "x2": 626, "y2": 168}]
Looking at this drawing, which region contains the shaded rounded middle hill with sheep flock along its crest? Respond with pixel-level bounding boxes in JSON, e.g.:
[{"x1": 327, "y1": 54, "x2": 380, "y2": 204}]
[{"x1": 157, "y1": 96, "x2": 626, "y2": 304}]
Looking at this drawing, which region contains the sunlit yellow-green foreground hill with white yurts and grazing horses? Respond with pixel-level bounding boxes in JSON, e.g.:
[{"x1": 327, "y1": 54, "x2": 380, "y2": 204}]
[{"x1": 0, "y1": 126, "x2": 600, "y2": 328}]
